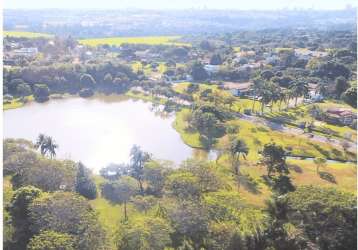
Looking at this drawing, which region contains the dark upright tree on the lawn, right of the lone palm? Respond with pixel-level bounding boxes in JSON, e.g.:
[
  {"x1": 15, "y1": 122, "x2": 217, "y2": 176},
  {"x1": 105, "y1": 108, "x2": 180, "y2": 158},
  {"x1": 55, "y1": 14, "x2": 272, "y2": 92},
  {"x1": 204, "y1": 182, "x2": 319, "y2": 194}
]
[{"x1": 262, "y1": 143, "x2": 288, "y2": 178}]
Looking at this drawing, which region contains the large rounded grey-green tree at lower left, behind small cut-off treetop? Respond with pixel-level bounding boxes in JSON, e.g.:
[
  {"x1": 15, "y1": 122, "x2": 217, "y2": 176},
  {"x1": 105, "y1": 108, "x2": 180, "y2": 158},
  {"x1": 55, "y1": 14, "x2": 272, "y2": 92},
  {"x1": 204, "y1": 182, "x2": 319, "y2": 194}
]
[{"x1": 29, "y1": 191, "x2": 107, "y2": 250}]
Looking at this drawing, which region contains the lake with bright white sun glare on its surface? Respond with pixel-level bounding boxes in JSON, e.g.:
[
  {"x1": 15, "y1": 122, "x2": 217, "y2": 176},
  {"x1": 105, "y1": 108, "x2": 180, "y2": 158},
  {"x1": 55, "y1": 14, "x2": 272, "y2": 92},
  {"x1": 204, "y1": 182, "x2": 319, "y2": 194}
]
[{"x1": 4, "y1": 96, "x2": 213, "y2": 172}]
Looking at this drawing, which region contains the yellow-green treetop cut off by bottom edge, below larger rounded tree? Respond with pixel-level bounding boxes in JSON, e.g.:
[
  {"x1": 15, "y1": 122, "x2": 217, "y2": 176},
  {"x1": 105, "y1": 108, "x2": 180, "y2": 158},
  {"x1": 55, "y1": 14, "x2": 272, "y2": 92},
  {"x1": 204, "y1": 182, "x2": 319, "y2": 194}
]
[{"x1": 27, "y1": 231, "x2": 75, "y2": 250}]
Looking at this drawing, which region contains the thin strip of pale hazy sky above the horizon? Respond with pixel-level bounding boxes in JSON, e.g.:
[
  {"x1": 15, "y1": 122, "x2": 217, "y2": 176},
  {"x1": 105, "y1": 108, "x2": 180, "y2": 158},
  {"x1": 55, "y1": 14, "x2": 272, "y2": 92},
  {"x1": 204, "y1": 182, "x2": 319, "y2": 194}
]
[{"x1": 4, "y1": 0, "x2": 357, "y2": 10}]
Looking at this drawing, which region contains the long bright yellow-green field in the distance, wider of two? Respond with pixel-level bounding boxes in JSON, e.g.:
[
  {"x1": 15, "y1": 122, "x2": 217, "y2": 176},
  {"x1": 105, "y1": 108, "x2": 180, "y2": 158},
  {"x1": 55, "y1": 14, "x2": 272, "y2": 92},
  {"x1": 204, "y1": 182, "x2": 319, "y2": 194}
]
[{"x1": 79, "y1": 36, "x2": 190, "y2": 46}]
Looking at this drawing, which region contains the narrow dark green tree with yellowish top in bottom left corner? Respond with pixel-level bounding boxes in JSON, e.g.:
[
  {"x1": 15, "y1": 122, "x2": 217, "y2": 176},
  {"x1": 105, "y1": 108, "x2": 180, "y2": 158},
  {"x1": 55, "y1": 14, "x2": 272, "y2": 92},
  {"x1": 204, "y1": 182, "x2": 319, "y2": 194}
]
[{"x1": 7, "y1": 186, "x2": 42, "y2": 249}]
